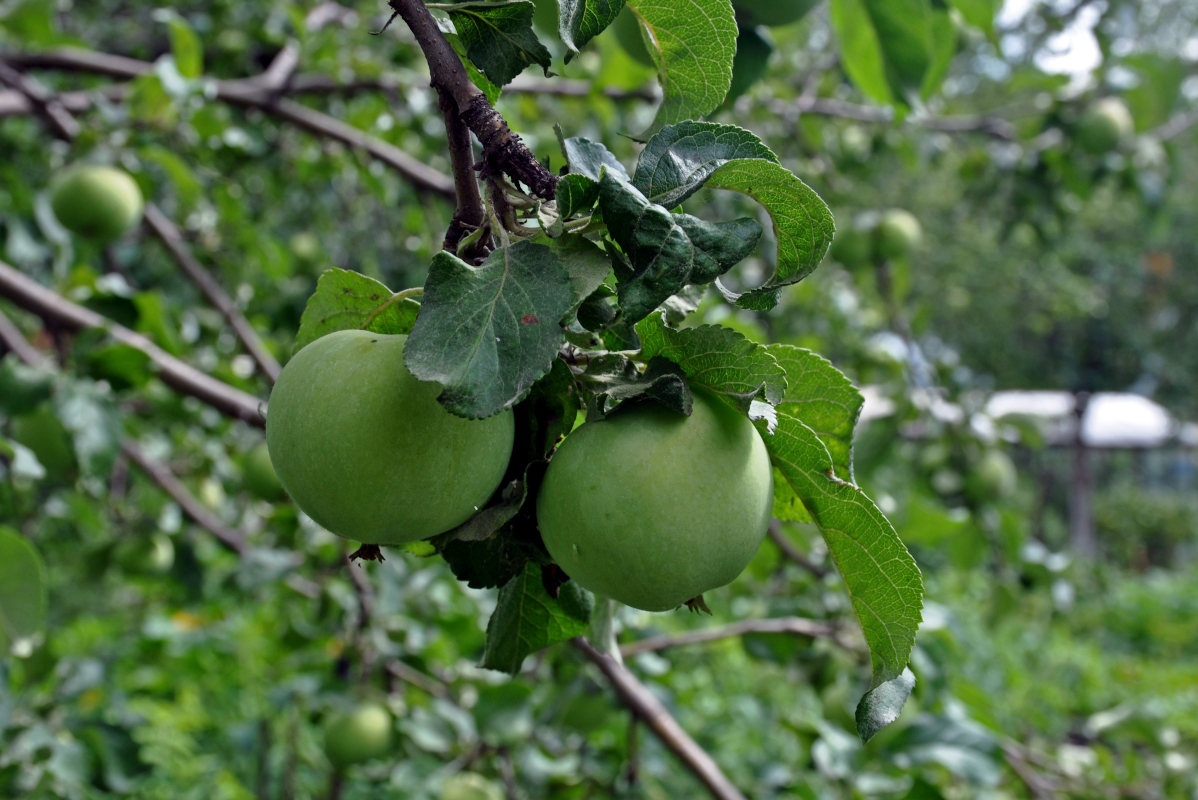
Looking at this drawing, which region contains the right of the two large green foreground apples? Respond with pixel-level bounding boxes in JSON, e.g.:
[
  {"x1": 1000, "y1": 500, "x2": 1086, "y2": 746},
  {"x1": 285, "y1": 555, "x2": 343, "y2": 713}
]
[{"x1": 537, "y1": 389, "x2": 774, "y2": 611}]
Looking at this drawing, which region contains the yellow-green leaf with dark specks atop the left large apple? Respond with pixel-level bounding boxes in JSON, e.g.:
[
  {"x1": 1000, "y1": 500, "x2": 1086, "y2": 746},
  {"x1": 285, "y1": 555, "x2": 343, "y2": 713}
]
[{"x1": 295, "y1": 267, "x2": 420, "y2": 352}]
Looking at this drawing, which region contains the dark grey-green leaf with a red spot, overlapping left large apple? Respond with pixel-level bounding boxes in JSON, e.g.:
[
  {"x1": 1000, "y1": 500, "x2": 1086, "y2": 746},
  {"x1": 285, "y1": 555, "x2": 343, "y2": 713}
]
[{"x1": 404, "y1": 242, "x2": 574, "y2": 419}]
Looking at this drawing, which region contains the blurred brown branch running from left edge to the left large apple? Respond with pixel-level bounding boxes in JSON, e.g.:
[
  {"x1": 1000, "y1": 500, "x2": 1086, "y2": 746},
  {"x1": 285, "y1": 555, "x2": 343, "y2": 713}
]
[{"x1": 0, "y1": 261, "x2": 266, "y2": 428}]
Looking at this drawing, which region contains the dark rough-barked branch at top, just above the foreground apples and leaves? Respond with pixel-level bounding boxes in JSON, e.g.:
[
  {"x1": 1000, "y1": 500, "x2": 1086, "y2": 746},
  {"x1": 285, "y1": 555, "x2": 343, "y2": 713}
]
[{"x1": 389, "y1": 0, "x2": 557, "y2": 200}]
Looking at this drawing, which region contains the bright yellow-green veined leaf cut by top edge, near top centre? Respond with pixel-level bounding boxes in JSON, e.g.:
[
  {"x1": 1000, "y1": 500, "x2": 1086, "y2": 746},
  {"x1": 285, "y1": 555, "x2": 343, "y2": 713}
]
[{"x1": 627, "y1": 0, "x2": 737, "y2": 131}]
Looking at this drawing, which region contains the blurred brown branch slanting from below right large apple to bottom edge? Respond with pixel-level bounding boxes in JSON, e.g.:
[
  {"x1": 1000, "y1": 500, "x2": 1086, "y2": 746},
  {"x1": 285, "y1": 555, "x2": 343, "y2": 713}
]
[{"x1": 570, "y1": 638, "x2": 745, "y2": 800}]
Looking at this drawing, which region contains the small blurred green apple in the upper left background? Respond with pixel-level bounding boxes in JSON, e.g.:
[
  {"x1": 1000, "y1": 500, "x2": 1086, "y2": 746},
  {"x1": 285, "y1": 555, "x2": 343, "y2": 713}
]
[{"x1": 50, "y1": 164, "x2": 144, "y2": 244}]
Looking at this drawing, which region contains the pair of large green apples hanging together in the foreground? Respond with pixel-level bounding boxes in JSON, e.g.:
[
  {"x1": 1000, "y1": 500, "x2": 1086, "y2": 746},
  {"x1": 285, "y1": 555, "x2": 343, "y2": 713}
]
[{"x1": 266, "y1": 331, "x2": 773, "y2": 611}]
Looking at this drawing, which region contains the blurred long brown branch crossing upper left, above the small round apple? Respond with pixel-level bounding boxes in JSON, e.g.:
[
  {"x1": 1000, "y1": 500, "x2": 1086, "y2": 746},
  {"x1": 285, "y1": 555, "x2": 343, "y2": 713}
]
[{"x1": 0, "y1": 49, "x2": 454, "y2": 198}]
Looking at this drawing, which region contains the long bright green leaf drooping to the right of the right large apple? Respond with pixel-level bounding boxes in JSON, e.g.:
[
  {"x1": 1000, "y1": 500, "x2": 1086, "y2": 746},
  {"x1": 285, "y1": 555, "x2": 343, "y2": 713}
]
[{"x1": 758, "y1": 411, "x2": 924, "y2": 689}]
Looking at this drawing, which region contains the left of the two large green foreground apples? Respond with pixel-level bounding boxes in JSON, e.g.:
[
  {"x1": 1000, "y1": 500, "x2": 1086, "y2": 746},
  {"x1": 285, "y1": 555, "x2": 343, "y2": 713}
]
[{"x1": 266, "y1": 331, "x2": 515, "y2": 545}]
